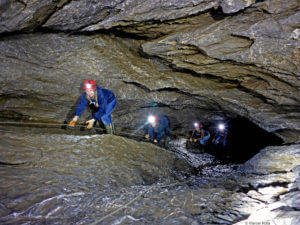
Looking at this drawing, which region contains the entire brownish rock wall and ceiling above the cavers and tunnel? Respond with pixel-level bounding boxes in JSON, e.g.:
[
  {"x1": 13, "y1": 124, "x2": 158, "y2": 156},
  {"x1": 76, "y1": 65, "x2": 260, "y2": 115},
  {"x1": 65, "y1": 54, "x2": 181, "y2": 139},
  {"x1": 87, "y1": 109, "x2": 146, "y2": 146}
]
[{"x1": 0, "y1": 0, "x2": 300, "y2": 142}]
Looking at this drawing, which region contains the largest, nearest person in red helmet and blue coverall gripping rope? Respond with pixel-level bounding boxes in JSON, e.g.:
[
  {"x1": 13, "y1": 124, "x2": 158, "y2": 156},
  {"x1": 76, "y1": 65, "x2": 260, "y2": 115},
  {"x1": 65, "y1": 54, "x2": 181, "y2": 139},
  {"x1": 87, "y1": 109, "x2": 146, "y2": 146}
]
[{"x1": 69, "y1": 80, "x2": 117, "y2": 134}]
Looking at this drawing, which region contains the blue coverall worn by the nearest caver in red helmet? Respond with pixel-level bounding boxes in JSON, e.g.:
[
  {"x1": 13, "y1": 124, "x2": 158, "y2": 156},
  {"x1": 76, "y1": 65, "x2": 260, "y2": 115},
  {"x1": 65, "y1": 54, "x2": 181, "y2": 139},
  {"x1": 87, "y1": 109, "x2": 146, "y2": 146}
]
[{"x1": 76, "y1": 87, "x2": 117, "y2": 126}]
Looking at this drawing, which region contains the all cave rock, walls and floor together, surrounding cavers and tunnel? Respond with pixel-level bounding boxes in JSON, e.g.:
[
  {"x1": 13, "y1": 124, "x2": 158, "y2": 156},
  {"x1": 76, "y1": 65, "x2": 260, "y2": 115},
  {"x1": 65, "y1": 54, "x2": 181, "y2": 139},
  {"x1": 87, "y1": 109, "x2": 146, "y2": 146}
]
[{"x1": 0, "y1": 0, "x2": 300, "y2": 224}]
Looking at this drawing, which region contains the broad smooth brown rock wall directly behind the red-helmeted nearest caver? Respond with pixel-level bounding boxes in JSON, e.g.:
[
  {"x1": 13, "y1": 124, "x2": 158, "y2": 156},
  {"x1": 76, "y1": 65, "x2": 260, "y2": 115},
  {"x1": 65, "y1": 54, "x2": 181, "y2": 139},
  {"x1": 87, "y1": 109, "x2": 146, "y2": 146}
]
[{"x1": 0, "y1": 34, "x2": 230, "y2": 132}]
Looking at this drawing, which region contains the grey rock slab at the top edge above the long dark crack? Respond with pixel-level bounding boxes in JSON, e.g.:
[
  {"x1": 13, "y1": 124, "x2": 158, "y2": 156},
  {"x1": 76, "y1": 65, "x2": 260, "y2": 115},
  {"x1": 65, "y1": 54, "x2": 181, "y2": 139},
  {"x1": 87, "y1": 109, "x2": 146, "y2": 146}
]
[{"x1": 44, "y1": 0, "x2": 219, "y2": 31}]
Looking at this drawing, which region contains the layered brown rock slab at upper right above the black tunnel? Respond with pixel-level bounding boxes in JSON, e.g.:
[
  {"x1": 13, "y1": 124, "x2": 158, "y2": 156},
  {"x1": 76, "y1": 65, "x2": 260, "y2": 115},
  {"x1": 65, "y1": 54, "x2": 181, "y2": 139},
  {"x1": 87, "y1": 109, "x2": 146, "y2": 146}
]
[{"x1": 143, "y1": 5, "x2": 300, "y2": 135}]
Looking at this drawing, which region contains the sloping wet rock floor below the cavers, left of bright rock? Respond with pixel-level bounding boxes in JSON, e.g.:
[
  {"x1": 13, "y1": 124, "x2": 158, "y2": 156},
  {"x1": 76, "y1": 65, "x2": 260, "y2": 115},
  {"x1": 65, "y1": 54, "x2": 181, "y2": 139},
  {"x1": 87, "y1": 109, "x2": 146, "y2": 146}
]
[{"x1": 0, "y1": 126, "x2": 245, "y2": 224}]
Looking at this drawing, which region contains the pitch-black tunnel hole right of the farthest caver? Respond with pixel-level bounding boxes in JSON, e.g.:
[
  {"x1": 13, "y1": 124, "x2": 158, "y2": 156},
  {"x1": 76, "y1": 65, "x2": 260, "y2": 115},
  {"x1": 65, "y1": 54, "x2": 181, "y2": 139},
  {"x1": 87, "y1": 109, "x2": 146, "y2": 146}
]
[{"x1": 209, "y1": 117, "x2": 283, "y2": 163}]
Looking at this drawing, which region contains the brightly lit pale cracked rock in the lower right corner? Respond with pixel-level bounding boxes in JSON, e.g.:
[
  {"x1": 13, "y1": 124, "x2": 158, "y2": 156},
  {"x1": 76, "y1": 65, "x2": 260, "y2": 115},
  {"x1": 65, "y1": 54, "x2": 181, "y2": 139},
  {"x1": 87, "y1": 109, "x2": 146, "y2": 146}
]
[{"x1": 237, "y1": 145, "x2": 300, "y2": 224}]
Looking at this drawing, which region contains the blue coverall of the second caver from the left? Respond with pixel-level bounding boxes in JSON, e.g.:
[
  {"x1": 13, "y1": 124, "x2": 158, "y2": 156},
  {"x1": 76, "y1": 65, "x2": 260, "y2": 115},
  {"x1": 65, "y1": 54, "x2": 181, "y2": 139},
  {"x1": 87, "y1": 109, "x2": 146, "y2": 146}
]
[{"x1": 147, "y1": 115, "x2": 171, "y2": 142}]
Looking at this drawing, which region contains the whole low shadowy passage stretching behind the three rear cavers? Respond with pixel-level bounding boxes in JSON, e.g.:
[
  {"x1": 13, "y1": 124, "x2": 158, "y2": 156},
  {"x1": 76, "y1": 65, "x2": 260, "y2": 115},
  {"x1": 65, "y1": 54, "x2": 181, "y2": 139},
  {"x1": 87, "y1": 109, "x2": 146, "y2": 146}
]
[{"x1": 125, "y1": 103, "x2": 283, "y2": 163}]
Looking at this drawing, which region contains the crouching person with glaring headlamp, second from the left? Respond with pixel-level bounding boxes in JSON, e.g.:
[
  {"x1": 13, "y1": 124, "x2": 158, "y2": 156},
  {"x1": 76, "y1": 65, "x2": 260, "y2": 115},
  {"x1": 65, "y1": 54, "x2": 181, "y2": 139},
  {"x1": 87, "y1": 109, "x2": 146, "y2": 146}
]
[{"x1": 145, "y1": 115, "x2": 170, "y2": 144}]
